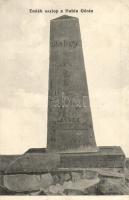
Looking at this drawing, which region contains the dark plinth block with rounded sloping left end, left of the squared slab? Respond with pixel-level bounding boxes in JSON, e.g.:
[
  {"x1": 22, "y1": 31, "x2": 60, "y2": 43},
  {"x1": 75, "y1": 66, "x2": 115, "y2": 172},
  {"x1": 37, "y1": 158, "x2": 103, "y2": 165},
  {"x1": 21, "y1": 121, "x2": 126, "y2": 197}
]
[{"x1": 5, "y1": 153, "x2": 60, "y2": 174}]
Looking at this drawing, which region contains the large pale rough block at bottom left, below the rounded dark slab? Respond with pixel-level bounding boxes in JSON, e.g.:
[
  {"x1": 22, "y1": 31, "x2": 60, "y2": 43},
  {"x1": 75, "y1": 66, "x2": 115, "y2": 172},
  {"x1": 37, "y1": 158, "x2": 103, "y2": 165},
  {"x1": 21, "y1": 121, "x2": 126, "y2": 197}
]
[{"x1": 4, "y1": 174, "x2": 40, "y2": 192}]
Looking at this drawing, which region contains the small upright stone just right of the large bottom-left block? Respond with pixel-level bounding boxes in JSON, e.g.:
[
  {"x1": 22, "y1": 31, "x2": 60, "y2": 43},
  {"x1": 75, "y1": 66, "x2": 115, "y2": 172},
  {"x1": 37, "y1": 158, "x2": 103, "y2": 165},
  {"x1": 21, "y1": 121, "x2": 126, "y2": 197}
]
[{"x1": 40, "y1": 173, "x2": 54, "y2": 190}]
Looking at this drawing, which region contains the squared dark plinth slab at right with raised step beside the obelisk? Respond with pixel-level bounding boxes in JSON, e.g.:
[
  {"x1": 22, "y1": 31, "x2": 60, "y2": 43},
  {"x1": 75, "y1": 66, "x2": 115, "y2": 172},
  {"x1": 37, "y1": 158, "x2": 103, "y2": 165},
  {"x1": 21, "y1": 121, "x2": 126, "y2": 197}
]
[{"x1": 60, "y1": 146, "x2": 125, "y2": 168}]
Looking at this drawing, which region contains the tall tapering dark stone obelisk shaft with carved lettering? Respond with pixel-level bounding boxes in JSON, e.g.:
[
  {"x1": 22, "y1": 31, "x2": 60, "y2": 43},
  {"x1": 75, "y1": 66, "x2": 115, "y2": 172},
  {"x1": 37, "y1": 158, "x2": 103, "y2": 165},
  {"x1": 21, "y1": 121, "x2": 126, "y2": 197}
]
[{"x1": 47, "y1": 15, "x2": 97, "y2": 153}]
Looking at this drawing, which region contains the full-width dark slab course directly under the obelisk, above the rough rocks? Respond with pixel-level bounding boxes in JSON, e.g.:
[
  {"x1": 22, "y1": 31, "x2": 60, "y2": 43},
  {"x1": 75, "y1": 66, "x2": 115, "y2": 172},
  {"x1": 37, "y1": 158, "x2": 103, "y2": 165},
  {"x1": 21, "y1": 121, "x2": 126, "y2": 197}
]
[{"x1": 0, "y1": 147, "x2": 125, "y2": 174}]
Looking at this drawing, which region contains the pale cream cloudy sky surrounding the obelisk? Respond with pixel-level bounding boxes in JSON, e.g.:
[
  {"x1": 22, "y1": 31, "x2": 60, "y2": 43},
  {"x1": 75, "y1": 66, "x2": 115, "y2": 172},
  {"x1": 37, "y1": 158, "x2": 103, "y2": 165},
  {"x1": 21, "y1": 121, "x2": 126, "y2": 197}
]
[{"x1": 0, "y1": 0, "x2": 129, "y2": 156}]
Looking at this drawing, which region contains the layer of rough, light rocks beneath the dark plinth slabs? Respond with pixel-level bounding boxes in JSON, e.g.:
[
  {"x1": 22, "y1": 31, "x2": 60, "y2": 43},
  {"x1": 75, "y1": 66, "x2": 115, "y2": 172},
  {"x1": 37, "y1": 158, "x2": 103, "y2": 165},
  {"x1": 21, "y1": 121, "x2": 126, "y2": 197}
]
[{"x1": 0, "y1": 169, "x2": 129, "y2": 196}]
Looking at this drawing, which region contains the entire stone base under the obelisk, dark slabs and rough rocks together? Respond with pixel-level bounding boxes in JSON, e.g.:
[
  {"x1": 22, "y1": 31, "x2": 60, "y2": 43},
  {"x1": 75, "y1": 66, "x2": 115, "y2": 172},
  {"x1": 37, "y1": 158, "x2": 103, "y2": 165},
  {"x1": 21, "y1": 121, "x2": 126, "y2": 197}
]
[{"x1": 0, "y1": 146, "x2": 129, "y2": 195}]
